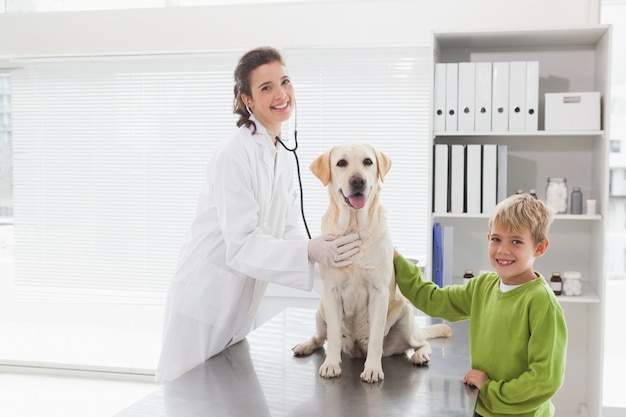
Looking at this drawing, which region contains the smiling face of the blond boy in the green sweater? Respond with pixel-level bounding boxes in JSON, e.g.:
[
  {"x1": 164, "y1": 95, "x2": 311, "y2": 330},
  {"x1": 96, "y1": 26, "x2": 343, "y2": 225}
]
[{"x1": 487, "y1": 222, "x2": 549, "y2": 285}]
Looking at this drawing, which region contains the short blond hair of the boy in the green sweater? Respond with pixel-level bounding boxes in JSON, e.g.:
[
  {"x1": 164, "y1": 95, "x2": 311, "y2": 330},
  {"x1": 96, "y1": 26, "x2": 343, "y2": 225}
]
[{"x1": 489, "y1": 193, "x2": 554, "y2": 244}]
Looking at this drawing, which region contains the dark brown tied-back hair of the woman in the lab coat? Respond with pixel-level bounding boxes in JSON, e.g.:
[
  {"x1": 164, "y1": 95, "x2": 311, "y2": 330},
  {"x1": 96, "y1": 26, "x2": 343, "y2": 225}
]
[{"x1": 233, "y1": 46, "x2": 284, "y2": 133}]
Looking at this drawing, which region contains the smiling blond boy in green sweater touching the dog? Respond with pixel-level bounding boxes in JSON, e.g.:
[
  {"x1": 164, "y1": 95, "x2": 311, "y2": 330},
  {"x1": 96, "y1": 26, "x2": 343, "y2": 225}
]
[{"x1": 394, "y1": 194, "x2": 567, "y2": 417}]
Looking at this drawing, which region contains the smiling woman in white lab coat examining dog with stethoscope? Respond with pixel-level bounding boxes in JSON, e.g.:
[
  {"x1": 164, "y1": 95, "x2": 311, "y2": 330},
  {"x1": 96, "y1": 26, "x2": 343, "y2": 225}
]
[{"x1": 156, "y1": 48, "x2": 360, "y2": 382}]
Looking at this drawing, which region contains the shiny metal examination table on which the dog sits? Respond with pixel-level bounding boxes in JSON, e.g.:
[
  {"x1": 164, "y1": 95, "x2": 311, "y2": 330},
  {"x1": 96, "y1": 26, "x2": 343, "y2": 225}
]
[{"x1": 116, "y1": 308, "x2": 477, "y2": 417}]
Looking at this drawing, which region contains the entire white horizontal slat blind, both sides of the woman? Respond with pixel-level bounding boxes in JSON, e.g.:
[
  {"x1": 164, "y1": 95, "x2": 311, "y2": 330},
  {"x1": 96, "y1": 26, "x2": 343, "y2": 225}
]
[{"x1": 12, "y1": 48, "x2": 429, "y2": 304}]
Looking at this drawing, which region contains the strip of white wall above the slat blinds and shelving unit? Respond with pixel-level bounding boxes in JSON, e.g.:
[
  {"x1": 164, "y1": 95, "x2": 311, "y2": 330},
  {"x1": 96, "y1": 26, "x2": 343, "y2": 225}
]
[{"x1": 0, "y1": 0, "x2": 600, "y2": 59}]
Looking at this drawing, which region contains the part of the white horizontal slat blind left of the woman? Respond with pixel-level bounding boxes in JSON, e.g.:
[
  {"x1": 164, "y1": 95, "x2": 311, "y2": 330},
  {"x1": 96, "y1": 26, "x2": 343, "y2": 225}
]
[{"x1": 13, "y1": 54, "x2": 238, "y2": 303}]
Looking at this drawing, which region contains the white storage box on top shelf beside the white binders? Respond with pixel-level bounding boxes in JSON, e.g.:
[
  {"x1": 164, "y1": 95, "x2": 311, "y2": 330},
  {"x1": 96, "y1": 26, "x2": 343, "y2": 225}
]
[{"x1": 544, "y1": 92, "x2": 600, "y2": 130}]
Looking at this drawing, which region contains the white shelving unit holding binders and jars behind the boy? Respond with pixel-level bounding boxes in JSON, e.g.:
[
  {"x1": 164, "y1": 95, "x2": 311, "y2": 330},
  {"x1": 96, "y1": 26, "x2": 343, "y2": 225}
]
[{"x1": 429, "y1": 25, "x2": 611, "y2": 417}]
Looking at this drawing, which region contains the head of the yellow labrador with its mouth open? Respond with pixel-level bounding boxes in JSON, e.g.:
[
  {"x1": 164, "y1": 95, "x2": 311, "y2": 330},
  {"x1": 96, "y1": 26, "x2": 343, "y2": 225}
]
[{"x1": 310, "y1": 144, "x2": 391, "y2": 210}]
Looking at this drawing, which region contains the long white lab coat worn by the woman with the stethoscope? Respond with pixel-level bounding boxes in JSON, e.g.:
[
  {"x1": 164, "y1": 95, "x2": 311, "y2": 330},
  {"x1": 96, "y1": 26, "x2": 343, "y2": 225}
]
[{"x1": 156, "y1": 115, "x2": 314, "y2": 382}]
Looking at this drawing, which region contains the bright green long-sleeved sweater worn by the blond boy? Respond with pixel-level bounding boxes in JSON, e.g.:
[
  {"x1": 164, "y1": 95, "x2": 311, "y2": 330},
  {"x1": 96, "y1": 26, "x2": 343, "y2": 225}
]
[{"x1": 394, "y1": 256, "x2": 567, "y2": 417}]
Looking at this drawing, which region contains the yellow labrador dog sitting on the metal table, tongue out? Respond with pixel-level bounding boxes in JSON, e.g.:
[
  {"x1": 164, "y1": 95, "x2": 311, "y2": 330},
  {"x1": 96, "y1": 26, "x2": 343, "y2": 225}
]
[{"x1": 293, "y1": 144, "x2": 452, "y2": 382}]
